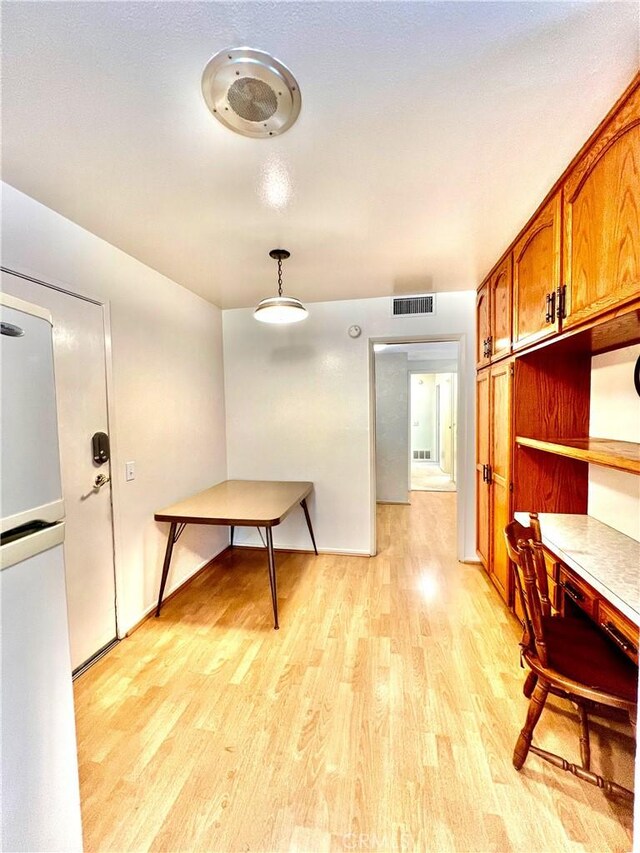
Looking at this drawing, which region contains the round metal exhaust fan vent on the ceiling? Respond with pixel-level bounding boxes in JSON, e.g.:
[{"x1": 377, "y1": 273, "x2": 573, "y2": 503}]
[{"x1": 202, "y1": 47, "x2": 302, "y2": 139}]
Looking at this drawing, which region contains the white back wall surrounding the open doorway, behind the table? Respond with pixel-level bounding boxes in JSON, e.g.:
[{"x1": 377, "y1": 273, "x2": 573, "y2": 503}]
[{"x1": 223, "y1": 291, "x2": 477, "y2": 561}]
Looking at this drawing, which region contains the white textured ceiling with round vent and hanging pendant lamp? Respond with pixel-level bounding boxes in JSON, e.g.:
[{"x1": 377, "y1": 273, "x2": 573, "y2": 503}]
[{"x1": 2, "y1": 0, "x2": 640, "y2": 307}]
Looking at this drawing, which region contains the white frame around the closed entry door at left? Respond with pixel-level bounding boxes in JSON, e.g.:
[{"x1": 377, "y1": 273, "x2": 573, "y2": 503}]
[{"x1": 0, "y1": 266, "x2": 125, "y2": 640}]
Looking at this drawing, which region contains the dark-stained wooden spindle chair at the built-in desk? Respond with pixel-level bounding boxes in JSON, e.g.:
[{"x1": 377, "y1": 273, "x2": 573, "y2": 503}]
[{"x1": 505, "y1": 513, "x2": 638, "y2": 800}]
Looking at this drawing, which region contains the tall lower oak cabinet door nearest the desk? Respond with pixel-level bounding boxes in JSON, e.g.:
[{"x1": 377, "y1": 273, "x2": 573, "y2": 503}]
[{"x1": 490, "y1": 362, "x2": 511, "y2": 604}]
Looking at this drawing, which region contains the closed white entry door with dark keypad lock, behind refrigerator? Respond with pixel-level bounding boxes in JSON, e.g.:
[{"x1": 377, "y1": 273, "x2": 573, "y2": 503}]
[{"x1": 2, "y1": 272, "x2": 116, "y2": 670}]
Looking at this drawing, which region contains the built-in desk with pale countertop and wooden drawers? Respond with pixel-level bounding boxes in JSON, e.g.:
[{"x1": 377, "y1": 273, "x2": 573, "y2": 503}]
[{"x1": 515, "y1": 512, "x2": 640, "y2": 663}]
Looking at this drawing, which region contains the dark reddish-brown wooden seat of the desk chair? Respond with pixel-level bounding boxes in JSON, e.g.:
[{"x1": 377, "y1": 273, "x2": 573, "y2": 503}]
[{"x1": 542, "y1": 616, "x2": 638, "y2": 703}]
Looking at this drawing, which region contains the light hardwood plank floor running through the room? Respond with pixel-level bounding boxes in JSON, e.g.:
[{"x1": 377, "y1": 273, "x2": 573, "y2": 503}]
[{"x1": 75, "y1": 492, "x2": 633, "y2": 852}]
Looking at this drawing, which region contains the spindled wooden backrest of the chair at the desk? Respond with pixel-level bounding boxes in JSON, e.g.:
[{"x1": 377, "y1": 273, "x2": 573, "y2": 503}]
[{"x1": 504, "y1": 513, "x2": 551, "y2": 665}]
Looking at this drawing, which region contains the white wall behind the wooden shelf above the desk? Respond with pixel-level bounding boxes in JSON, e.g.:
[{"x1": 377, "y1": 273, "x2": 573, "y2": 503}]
[{"x1": 589, "y1": 344, "x2": 640, "y2": 541}]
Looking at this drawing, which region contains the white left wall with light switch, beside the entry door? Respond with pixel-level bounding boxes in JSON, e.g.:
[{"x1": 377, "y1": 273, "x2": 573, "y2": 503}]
[{"x1": 2, "y1": 184, "x2": 227, "y2": 633}]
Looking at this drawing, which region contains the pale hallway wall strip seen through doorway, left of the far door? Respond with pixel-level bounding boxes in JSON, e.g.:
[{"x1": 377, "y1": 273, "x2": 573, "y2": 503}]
[{"x1": 375, "y1": 351, "x2": 409, "y2": 503}]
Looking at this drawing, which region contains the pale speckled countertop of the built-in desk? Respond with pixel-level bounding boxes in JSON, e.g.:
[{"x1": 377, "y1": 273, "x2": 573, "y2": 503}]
[{"x1": 515, "y1": 512, "x2": 640, "y2": 626}]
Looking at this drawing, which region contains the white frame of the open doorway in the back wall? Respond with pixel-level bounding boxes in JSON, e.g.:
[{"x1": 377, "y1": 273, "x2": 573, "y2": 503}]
[{"x1": 368, "y1": 334, "x2": 470, "y2": 561}]
